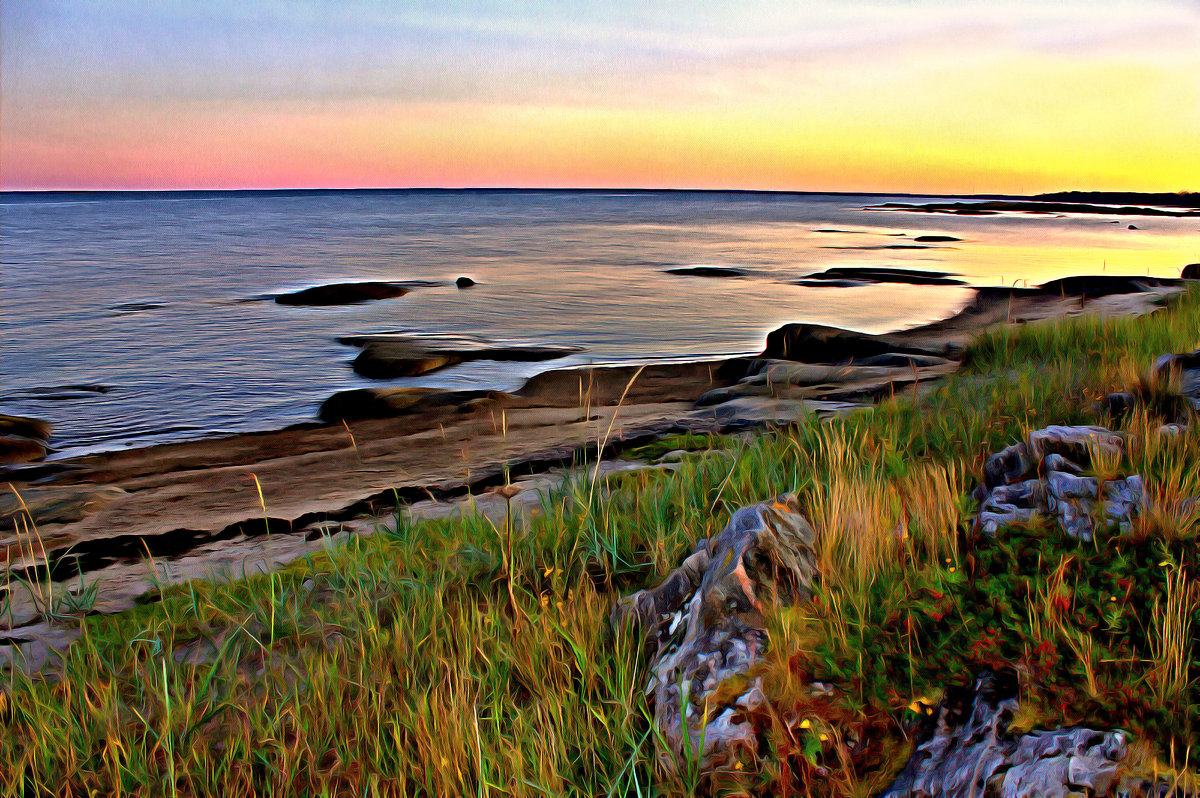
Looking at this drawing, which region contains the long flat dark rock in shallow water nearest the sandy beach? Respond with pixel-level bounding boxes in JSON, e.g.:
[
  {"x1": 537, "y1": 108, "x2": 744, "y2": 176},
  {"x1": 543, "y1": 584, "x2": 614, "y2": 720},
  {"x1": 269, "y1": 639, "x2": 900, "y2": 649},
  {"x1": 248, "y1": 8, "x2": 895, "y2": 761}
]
[{"x1": 338, "y1": 332, "x2": 583, "y2": 379}]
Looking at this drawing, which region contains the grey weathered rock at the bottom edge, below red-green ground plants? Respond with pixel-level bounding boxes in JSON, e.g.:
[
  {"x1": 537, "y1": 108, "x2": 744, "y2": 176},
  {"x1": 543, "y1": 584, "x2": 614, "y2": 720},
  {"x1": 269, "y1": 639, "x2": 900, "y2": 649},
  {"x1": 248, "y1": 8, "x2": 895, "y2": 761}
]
[{"x1": 882, "y1": 672, "x2": 1126, "y2": 798}]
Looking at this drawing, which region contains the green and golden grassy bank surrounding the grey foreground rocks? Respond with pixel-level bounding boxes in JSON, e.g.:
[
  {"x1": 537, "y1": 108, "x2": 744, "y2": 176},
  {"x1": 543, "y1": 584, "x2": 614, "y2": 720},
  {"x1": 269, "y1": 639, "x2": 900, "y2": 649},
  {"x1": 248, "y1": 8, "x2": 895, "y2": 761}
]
[{"x1": 7, "y1": 286, "x2": 1200, "y2": 798}]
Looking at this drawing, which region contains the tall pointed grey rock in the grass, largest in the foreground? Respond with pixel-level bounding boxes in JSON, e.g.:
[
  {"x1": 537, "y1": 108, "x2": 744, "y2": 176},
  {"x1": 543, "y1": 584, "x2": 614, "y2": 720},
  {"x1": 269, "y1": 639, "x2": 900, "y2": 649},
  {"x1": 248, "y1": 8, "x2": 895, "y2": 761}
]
[{"x1": 613, "y1": 496, "x2": 817, "y2": 769}]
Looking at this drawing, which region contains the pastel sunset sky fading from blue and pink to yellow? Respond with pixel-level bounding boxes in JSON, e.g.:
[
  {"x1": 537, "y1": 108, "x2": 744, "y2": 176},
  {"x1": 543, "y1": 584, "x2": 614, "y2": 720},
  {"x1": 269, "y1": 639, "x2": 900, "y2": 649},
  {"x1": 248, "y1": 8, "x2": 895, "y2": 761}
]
[{"x1": 0, "y1": 0, "x2": 1200, "y2": 193}]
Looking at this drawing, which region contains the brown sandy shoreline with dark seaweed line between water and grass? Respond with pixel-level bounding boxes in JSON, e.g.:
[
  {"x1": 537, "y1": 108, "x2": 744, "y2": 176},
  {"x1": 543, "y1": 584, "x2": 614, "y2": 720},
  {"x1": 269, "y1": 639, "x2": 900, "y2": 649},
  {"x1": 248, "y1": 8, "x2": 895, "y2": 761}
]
[{"x1": 0, "y1": 273, "x2": 1183, "y2": 659}]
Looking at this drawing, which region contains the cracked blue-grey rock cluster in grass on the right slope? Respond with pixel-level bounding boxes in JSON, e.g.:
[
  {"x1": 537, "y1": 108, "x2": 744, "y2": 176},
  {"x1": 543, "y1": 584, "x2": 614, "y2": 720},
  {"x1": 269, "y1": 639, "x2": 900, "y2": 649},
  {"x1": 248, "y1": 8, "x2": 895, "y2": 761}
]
[{"x1": 974, "y1": 426, "x2": 1145, "y2": 540}]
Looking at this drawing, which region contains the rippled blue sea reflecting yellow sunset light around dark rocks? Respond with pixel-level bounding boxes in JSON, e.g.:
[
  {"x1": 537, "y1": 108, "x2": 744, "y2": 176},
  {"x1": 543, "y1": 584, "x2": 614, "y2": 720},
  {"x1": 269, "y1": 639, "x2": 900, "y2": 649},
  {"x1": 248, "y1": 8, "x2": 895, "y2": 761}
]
[{"x1": 7, "y1": 191, "x2": 1200, "y2": 456}]
